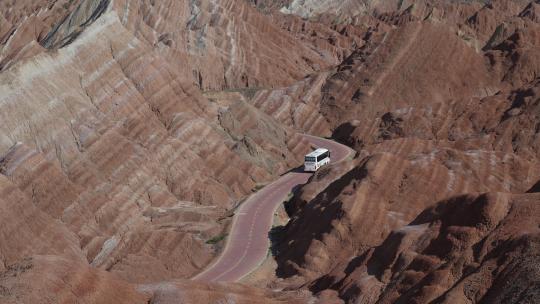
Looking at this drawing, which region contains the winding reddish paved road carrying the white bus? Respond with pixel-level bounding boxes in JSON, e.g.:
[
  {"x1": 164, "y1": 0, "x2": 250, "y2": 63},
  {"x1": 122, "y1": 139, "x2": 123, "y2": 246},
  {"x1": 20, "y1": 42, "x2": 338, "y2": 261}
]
[{"x1": 193, "y1": 135, "x2": 352, "y2": 282}]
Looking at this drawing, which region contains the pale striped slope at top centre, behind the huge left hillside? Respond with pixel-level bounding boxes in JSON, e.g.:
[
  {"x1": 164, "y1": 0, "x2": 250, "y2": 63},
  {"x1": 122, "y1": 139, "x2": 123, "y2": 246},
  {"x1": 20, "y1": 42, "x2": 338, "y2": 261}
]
[{"x1": 109, "y1": 0, "x2": 337, "y2": 90}]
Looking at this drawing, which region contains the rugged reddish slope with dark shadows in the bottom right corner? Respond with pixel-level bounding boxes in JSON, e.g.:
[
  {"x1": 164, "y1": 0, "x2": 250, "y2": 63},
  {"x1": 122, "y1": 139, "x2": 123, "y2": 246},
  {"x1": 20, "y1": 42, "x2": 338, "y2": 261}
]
[{"x1": 313, "y1": 193, "x2": 540, "y2": 303}]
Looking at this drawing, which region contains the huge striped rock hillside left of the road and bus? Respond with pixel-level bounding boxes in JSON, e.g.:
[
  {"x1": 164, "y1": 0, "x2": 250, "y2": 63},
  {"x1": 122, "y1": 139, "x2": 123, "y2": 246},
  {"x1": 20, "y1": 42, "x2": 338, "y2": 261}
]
[{"x1": 0, "y1": 1, "x2": 316, "y2": 296}]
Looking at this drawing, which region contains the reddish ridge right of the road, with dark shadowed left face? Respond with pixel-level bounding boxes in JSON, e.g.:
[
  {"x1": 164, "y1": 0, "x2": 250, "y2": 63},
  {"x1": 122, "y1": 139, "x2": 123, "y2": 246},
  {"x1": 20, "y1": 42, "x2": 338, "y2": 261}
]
[{"x1": 278, "y1": 145, "x2": 540, "y2": 278}]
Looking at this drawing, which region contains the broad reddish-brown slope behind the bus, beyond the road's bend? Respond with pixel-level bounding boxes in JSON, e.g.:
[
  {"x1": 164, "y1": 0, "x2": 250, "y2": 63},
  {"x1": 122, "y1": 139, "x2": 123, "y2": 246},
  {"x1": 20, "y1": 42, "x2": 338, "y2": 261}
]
[{"x1": 255, "y1": 18, "x2": 496, "y2": 131}]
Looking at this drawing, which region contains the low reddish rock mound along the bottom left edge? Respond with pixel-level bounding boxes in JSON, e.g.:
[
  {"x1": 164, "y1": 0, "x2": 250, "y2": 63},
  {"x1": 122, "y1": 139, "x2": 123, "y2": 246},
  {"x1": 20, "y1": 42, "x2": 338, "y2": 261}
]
[{"x1": 0, "y1": 255, "x2": 313, "y2": 304}]
